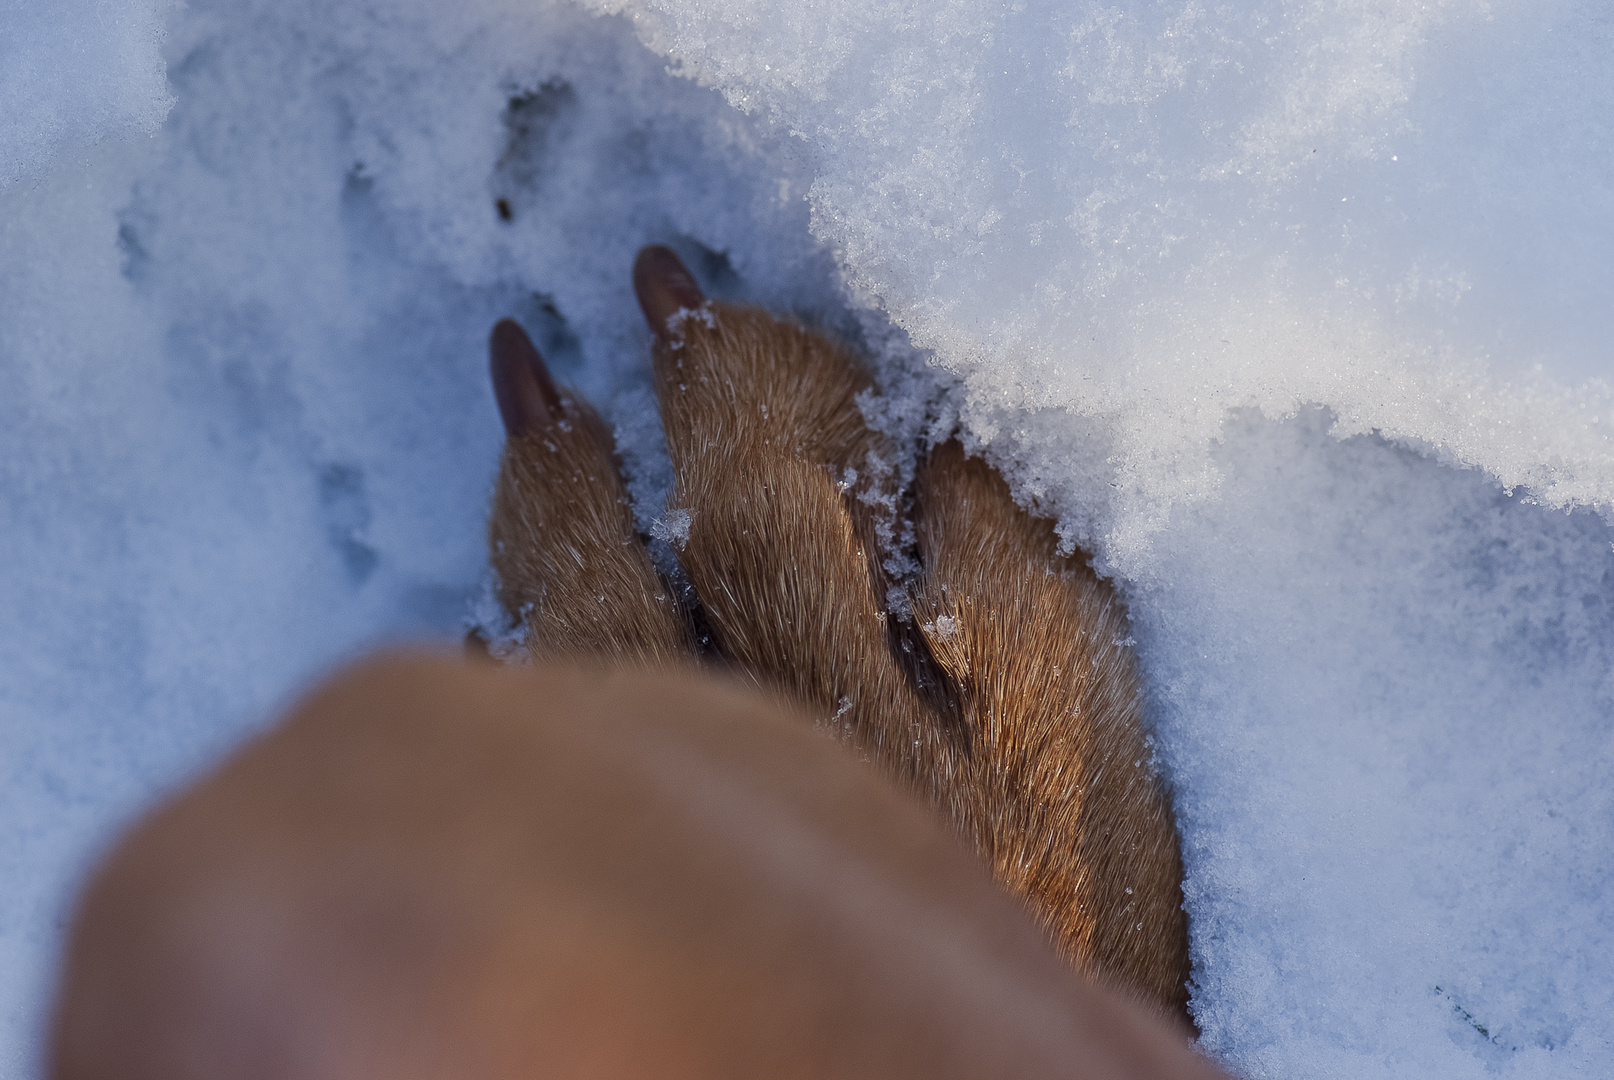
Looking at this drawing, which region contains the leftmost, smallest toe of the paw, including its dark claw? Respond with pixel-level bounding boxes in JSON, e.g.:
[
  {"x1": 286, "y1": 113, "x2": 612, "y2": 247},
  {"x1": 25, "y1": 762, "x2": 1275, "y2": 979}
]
[{"x1": 487, "y1": 320, "x2": 689, "y2": 665}]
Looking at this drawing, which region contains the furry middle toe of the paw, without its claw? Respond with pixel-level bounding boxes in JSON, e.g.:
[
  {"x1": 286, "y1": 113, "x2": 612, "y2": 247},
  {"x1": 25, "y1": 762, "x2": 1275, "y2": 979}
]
[{"x1": 655, "y1": 303, "x2": 957, "y2": 794}]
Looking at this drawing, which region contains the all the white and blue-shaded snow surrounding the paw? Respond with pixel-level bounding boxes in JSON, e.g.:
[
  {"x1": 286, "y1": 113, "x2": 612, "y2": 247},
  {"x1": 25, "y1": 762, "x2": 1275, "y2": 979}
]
[{"x1": 0, "y1": 0, "x2": 1614, "y2": 1078}]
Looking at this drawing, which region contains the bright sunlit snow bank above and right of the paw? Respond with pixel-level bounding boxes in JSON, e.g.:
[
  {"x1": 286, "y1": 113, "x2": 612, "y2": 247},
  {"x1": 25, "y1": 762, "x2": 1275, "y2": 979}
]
[{"x1": 594, "y1": 0, "x2": 1614, "y2": 575}]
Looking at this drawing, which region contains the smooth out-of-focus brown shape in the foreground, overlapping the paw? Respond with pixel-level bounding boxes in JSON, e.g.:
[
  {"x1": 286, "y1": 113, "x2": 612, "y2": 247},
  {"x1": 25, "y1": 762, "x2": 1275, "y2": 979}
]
[{"x1": 50, "y1": 655, "x2": 1220, "y2": 1080}]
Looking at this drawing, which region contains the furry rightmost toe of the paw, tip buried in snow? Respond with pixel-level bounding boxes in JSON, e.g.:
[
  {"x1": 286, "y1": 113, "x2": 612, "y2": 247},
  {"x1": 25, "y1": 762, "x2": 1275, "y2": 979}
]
[{"x1": 914, "y1": 442, "x2": 1188, "y2": 1017}]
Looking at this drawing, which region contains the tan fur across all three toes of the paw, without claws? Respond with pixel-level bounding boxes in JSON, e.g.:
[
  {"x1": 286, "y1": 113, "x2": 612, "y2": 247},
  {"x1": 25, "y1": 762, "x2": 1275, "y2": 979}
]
[{"x1": 491, "y1": 303, "x2": 1188, "y2": 1017}]
